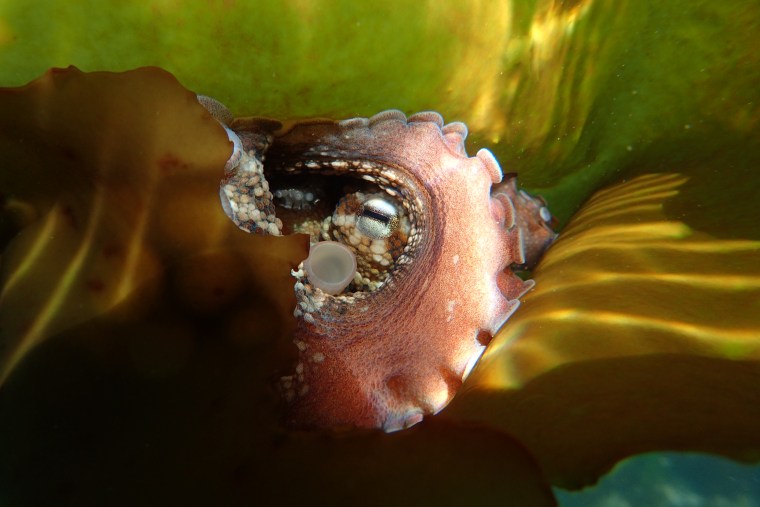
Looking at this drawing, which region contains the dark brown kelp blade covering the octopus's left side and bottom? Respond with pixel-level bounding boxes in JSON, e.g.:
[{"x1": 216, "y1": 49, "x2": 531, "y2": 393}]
[{"x1": 0, "y1": 68, "x2": 554, "y2": 507}]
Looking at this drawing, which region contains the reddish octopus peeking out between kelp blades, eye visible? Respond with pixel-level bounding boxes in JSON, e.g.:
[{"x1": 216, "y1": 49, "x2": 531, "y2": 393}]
[{"x1": 198, "y1": 96, "x2": 556, "y2": 432}]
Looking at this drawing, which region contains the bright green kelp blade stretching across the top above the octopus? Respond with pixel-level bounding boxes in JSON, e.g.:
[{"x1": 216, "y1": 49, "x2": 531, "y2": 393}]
[{"x1": 0, "y1": 0, "x2": 760, "y2": 224}]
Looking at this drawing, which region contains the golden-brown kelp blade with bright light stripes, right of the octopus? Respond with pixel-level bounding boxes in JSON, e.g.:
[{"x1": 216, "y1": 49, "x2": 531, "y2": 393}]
[{"x1": 442, "y1": 169, "x2": 760, "y2": 487}]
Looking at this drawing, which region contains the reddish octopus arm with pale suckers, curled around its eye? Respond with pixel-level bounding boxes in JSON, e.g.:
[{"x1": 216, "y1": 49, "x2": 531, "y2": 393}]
[{"x1": 202, "y1": 100, "x2": 554, "y2": 431}]
